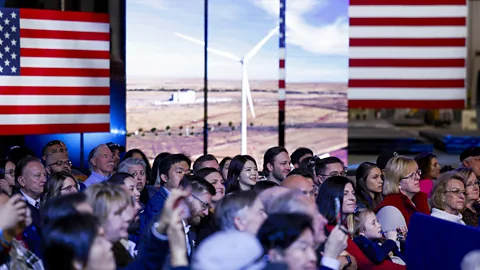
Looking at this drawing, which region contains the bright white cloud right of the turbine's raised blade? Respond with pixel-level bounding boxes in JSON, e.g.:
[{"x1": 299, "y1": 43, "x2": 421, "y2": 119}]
[{"x1": 251, "y1": 0, "x2": 348, "y2": 55}]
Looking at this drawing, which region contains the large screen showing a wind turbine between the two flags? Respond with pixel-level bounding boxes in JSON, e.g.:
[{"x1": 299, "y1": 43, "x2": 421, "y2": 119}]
[{"x1": 127, "y1": 0, "x2": 348, "y2": 168}]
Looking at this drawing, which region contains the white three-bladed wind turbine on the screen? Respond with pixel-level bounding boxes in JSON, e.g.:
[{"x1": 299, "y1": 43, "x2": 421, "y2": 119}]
[{"x1": 174, "y1": 26, "x2": 278, "y2": 155}]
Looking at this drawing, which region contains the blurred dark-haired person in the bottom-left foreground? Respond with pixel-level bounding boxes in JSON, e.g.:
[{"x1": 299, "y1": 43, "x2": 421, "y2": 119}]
[{"x1": 42, "y1": 214, "x2": 115, "y2": 270}]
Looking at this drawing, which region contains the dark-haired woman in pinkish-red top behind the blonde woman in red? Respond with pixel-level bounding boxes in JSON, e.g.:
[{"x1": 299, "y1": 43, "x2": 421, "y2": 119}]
[{"x1": 415, "y1": 152, "x2": 441, "y2": 198}]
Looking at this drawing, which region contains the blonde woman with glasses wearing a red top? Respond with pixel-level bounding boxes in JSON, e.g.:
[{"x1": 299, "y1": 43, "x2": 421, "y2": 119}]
[{"x1": 375, "y1": 156, "x2": 430, "y2": 232}]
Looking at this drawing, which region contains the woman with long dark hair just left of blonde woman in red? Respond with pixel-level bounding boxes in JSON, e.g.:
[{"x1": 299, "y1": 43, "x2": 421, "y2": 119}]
[{"x1": 355, "y1": 162, "x2": 383, "y2": 210}]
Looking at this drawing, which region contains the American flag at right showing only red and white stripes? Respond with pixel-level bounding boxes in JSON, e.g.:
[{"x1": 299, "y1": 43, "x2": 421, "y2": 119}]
[{"x1": 348, "y1": 0, "x2": 468, "y2": 109}]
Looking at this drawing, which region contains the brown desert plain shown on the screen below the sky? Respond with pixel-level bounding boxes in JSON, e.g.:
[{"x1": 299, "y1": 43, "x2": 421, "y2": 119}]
[{"x1": 127, "y1": 78, "x2": 347, "y2": 168}]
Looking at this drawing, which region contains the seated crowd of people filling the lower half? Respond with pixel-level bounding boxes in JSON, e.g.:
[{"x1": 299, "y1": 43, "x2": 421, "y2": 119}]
[{"x1": 0, "y1": 140, "x2": 480, "y2": 270}]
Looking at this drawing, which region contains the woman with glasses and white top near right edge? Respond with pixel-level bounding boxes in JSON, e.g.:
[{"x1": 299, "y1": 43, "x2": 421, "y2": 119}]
[{"x1": 430, "y1": 171, "x2": 467, "y2": 225}]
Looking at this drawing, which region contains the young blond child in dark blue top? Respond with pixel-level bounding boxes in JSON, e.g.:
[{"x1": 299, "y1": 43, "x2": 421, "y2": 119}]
[{"x1": 353, "y1": 209, "x2": 405, "y2": 265}]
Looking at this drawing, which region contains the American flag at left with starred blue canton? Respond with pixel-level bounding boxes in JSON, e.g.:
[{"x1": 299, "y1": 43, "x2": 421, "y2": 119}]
[{"x1": 0, "y1": 8, "x2": 110, "y2": 135}]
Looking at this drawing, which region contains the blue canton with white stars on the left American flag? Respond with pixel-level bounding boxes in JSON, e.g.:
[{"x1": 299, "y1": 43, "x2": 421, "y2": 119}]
[{"x1": 0, "y1": 8, "x2": 20, "y2": 76}]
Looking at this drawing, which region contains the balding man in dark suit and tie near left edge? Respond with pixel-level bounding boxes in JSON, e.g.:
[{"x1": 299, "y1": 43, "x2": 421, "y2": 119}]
[{"x1": 15, "y1": 156, "x2": 47, "y2": 258}]
